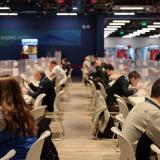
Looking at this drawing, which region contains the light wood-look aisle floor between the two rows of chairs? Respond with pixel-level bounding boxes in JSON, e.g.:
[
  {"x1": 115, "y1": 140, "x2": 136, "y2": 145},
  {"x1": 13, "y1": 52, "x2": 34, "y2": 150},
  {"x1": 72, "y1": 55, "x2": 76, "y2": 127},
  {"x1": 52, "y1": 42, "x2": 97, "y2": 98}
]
[{"x1": 51, "y1": 82, "x2": 119, "y2": 160}]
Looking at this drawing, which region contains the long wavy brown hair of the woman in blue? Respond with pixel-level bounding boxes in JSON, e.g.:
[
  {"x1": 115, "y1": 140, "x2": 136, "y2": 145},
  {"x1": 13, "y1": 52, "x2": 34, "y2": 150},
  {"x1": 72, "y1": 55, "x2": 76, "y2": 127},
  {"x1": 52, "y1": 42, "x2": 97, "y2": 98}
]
[{"x1": 0, "y1": 76, "x2": 37, "y2": 136}]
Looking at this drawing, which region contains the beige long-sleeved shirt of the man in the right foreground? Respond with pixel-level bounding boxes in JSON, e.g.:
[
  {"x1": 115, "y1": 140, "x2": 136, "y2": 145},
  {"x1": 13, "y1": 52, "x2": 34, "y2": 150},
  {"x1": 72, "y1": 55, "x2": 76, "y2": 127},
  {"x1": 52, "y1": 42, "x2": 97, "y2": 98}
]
[{"x1": 122, "y1": 98, "x2": 160, "y2": 150}]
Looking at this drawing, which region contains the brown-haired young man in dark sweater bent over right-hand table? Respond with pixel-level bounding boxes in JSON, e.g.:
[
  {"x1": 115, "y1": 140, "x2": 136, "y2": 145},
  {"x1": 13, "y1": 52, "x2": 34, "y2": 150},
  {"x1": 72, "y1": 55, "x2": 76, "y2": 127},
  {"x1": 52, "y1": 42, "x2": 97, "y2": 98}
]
[{"x1": 106, "y1": 71, "x2": 141, "y2": 110}]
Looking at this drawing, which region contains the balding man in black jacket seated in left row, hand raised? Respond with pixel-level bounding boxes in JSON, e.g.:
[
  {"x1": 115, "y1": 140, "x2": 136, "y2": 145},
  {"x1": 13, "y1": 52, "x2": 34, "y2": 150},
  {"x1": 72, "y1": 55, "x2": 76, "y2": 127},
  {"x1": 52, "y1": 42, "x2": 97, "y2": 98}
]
[{"x1": 28, "y1": 70, "x2": 56, "y2": 112}]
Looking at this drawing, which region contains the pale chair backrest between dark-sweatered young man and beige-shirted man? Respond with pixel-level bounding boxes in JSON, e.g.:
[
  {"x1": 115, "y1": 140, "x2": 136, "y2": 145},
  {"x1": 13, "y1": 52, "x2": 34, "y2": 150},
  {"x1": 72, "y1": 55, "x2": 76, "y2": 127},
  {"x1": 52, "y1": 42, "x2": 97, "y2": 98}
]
[{"x1": 116, "y1": 98, "x2": 129, "y2": 119}]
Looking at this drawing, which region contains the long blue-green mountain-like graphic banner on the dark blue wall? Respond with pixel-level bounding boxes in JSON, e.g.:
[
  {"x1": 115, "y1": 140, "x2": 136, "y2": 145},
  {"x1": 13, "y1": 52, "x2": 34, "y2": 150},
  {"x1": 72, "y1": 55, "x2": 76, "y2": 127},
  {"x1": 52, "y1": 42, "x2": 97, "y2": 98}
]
[{"x1": 0, "y1": 30, "x2": 81, "y2": 46}]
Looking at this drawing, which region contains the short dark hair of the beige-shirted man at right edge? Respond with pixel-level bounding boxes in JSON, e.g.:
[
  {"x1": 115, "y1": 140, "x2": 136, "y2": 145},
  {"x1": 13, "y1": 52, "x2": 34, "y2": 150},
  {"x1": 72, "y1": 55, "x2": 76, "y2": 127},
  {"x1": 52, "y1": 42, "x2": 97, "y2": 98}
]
[{"x1": 151, "y1": 78, "x2": 160, "y2": 98}]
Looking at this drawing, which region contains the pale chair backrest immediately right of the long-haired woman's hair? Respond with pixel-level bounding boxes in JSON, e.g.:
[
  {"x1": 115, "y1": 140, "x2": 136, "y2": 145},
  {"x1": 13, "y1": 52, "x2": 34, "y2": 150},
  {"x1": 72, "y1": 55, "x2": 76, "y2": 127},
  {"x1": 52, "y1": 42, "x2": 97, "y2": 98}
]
[{"x1": 31, "y1": 106, "x2": 47, "y2": 120}]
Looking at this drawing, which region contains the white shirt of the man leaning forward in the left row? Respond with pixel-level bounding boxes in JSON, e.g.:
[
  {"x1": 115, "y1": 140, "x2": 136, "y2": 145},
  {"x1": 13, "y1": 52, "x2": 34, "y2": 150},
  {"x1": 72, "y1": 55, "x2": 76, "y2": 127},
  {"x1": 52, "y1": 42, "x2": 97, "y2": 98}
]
[{"x1": 52, "y1": 65, "x2": 67, "y2": 84}]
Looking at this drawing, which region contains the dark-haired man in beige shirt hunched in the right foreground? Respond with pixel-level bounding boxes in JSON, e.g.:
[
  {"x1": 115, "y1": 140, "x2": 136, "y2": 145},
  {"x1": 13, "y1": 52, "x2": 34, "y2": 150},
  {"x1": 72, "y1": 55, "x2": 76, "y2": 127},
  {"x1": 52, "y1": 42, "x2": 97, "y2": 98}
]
[{"x1": 122, "y1": 79, "x2": 160, "y2": 160}]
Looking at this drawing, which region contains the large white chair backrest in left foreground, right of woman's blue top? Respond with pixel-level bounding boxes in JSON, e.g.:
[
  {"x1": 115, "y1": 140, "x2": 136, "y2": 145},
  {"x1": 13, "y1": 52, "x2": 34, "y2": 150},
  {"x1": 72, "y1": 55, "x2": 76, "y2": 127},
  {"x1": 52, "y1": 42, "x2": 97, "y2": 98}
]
[{"x1": 26, "y1": 130, "x2": 51, "y2": 160}]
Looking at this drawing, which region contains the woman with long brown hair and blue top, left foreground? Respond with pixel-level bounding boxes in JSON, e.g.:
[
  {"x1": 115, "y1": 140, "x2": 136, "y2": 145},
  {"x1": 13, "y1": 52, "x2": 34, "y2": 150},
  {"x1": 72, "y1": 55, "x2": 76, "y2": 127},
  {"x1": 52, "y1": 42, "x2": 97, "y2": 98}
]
[{"x1": 0, "y1": 76, "x2": 37, "y2": 160}]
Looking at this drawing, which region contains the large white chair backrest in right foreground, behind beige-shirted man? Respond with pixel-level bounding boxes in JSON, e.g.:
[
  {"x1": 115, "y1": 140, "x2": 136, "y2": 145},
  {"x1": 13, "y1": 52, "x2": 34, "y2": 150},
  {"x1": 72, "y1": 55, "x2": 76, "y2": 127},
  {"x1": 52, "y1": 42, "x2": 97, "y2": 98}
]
[{"x1": 111, "y1": 127, "x2": 136, "y2": 160}]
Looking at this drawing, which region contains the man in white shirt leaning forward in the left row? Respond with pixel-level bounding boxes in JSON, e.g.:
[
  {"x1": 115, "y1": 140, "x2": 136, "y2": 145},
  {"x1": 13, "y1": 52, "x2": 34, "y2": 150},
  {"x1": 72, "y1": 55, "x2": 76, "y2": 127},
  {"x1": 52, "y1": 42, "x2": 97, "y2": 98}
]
[{"x1": 48, "y1": 60, "x2": 67, "y2": 86}]
